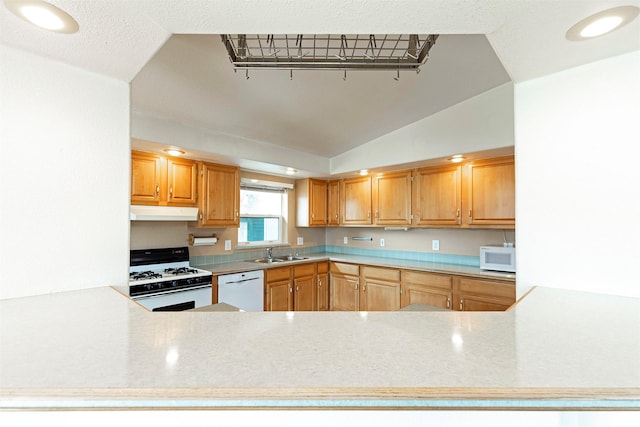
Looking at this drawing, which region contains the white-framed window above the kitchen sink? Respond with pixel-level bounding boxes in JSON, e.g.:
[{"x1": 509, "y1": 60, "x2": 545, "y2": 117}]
[{"x1": 238, "y1": 186, "x2": 286, "y2": 245}]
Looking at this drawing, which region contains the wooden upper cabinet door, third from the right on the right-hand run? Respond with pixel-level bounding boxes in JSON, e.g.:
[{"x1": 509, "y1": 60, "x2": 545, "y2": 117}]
[{"x1": 372, "y1": 170, "x2": 411, "y2": 226}]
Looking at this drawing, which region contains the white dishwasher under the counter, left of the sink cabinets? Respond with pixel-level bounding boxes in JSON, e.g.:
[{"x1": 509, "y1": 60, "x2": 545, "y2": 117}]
[{"x1": 218, "y1": 270, "x2": 264, "y2": 311}]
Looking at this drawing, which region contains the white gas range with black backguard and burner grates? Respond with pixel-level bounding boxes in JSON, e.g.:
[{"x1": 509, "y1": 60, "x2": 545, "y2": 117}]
[{"x1": 129, "y1": 247, "x2": 213, "y2": 311}]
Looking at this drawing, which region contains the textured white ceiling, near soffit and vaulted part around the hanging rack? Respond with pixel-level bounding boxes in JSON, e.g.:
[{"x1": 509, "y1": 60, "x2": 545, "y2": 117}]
[{"x1": 0, "y1": 0, "x2": 640, "y2": 174}]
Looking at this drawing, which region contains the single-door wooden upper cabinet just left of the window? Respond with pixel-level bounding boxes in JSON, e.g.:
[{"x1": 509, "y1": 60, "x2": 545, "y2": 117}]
[{"x1": 198, "y1": 162, "x2": 240, "y2": 227}]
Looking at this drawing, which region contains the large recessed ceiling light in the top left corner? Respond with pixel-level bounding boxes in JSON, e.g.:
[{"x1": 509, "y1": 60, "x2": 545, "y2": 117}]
[{"x1": 4, "y1": 0, "x2": 80, "y2": 34}]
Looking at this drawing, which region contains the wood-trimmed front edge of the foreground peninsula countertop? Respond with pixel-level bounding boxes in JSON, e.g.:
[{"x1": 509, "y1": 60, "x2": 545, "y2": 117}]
[{"x1": 0, "y1": 387, "x2": 640, "y2": 410}]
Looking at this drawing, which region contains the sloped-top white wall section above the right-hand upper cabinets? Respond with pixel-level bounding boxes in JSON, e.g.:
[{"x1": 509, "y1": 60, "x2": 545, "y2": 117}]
[{"x1": 331, "y1": 83, "x2": 514, "y2": 174}]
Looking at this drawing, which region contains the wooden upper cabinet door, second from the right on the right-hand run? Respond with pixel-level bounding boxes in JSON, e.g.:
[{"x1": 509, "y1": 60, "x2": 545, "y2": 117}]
[{"x1": 413, "y1": 165, "x2": 462, "y2": 227}]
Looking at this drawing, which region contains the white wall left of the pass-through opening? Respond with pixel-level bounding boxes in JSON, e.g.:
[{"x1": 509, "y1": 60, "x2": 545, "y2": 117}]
[{"x1": 0, "y1": 45, "x2": 130, "y2": 299}]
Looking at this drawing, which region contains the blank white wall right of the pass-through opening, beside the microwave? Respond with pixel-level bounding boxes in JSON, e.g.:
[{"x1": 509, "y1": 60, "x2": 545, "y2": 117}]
[{"x1": 515, "y1": 51, "x2": 640, "y2": 297}]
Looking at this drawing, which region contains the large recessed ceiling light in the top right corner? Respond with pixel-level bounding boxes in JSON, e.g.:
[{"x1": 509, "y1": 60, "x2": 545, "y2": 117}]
[{"x1": 566, "y1": 6, "x2": 640, "y2": 41}]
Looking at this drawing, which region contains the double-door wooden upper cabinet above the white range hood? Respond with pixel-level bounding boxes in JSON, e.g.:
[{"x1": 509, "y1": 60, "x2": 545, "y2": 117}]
[{"x1": 131, "y1": 151, "x2": 197, "y2": 206}]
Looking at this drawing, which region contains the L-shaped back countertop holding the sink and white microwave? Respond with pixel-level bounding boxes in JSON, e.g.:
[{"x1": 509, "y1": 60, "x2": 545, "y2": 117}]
[{"x1": 198, "y1": 252, "x2": 516, "y2": 281}]
